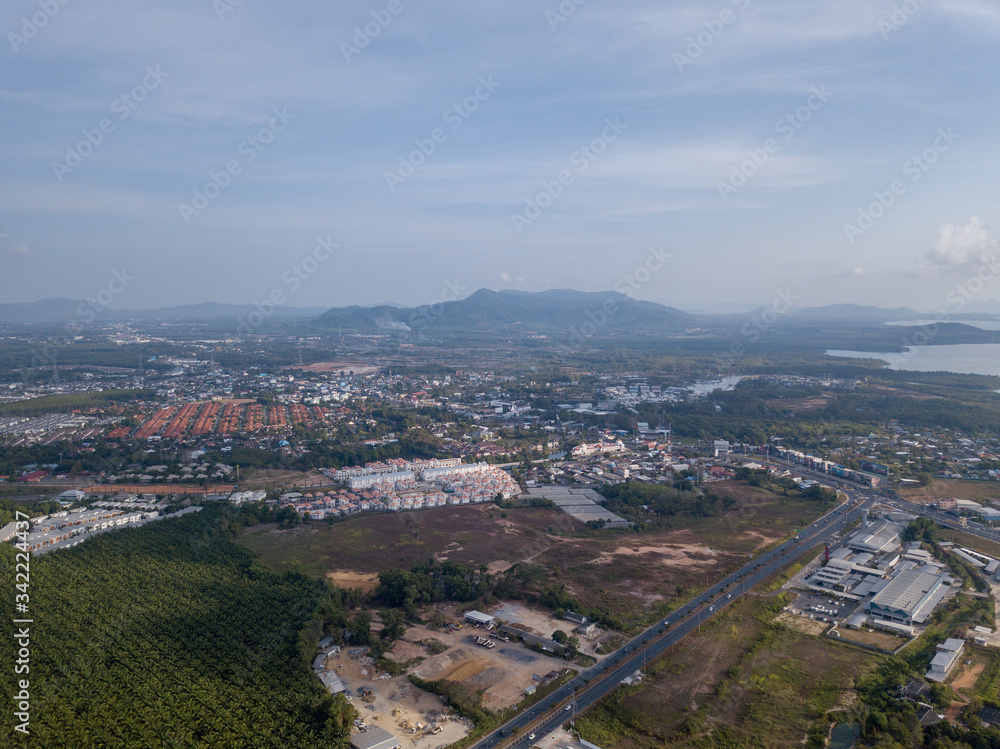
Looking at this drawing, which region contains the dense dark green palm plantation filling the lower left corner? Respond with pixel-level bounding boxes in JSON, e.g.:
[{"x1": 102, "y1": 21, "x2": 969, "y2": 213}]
[{"x1": 0, "y1": 505, "x2": 355, "y2": 749}]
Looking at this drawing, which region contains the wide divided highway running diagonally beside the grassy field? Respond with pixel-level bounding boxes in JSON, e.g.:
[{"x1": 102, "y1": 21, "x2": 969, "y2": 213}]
[{"x1": 472, "y1": 487, "x2": 875, "y2": 749}]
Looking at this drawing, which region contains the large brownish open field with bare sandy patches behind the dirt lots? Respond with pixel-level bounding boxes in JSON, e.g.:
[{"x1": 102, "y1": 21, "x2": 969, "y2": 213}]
[{"x1": 242, "y1": 481, "x2": 822, "y2": 616}]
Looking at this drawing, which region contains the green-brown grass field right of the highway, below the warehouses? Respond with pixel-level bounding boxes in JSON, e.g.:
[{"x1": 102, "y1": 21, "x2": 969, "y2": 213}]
[{"x1": 577, "y1": 596, "x2": 876, "y2": 749}]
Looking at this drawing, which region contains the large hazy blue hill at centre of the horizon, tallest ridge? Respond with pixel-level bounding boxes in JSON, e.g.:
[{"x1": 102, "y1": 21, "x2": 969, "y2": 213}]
[{"x1": 317, "y1": 289, "x2": 697, "y2": 333}]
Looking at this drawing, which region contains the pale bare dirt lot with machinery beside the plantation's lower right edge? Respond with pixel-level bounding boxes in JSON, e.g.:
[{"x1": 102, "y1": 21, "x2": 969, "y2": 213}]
[{"x1": 328, "y1": 649, "x2": 472, "y2": 749}]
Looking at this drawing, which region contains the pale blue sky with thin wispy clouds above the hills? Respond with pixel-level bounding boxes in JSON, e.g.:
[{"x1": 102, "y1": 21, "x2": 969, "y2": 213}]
[{"x1": 0, "y1": 0, "x2": 1000, "y2": 311}]
